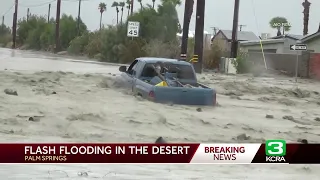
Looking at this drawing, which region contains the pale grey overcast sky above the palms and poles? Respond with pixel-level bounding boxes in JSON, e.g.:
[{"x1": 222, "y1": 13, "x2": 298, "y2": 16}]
[{"x1": 0, "y1": 0, "x2": 320, "y2": 35}]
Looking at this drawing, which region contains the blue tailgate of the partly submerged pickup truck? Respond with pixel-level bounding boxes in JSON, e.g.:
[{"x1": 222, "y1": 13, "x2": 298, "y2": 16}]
[{"x1": 154, "y1": 87, "x2": 216, "y2": 105}]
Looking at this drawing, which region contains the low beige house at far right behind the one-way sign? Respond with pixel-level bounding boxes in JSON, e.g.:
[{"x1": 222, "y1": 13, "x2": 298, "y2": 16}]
[{"x1": 240, "y1": 31, "x2": 320, "y2": 54}]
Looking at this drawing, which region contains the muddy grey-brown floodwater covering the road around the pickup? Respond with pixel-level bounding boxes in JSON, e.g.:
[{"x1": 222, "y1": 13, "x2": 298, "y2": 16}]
[{"x1": 0, "y1": 49, "x2": 320, "y2": 180}]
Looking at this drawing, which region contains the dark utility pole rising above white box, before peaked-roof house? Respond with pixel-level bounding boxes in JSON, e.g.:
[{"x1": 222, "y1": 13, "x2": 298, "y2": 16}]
[{"x1": 231, "y1": 0, "x2": 240, "y2": 58}]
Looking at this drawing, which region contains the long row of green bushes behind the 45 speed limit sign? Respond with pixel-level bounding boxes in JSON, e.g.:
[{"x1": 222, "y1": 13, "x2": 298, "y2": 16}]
[{"x1": 6, "y1": 1, "x2": 182, "y2": 63}]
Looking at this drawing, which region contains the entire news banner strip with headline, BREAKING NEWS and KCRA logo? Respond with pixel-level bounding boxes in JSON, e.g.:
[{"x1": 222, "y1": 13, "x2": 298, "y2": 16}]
[{"x1": 0, "y1": 140, "x2": 320, "y2": 164}]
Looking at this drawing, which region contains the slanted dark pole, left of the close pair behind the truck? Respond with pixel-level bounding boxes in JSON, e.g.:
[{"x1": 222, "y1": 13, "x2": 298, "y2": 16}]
[{"x1": 180, "y1": 0, "x2": 194, "y2": 61}]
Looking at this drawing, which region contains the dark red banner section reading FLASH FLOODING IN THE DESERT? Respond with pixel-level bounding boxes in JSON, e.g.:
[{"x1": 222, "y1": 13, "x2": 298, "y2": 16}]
[{"x1": 0, "y1": 144, "x2": 199, "y2": 163}]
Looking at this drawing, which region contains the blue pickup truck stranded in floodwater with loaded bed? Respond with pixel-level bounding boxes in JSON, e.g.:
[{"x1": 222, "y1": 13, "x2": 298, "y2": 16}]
[{"x1": 118, "y1": 57, "x2": 216, "y2": 106}]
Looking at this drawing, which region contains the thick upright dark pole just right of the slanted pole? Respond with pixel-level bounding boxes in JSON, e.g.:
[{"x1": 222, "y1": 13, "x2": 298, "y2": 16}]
[{"x1": 194, "y1": 0, "x2": 206, "y2": 73}]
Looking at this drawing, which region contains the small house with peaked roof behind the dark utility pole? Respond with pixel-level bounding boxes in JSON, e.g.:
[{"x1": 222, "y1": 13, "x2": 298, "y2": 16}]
[{"x1": 211, "y1": 30, "x2": 259, "y2": 51}]
